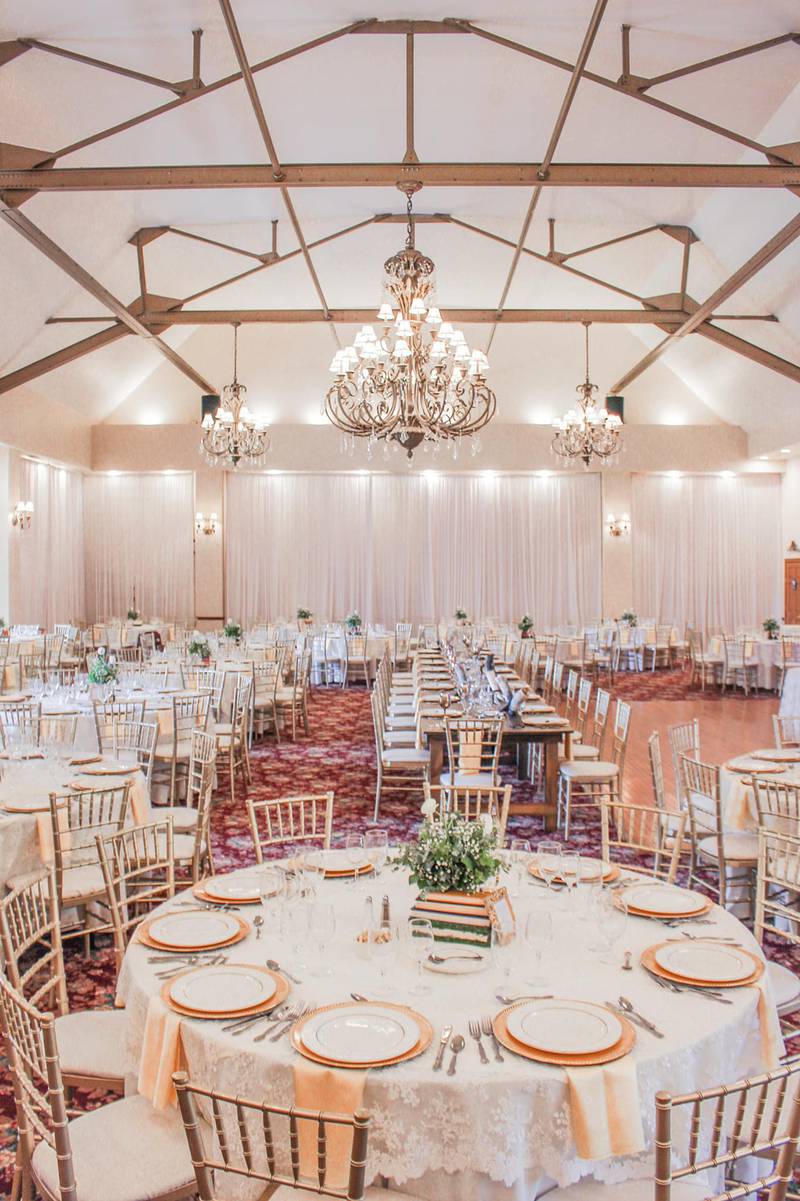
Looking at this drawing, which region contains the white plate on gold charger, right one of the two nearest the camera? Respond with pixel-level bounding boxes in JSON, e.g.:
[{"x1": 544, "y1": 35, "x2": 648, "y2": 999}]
[{"x1": 507, "y1": 1000, "x2": 622, "y2": 1054}]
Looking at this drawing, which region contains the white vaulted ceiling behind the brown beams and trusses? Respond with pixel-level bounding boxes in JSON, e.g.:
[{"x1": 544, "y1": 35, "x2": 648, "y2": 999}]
[{"x1": 0, "y1": 0, "x2": 800, "y2": 453}]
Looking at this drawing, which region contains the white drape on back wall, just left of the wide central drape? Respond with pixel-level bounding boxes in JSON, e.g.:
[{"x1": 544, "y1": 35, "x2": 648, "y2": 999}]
[{"x1": 85, "y1": 473, "x2": 195, "y2": 621}]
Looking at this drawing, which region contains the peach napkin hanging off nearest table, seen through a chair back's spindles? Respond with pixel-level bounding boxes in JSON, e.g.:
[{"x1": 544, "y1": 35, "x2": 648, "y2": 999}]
[{"x1": 292, "y1": 1059, "x2": 366, "y2": 1189}]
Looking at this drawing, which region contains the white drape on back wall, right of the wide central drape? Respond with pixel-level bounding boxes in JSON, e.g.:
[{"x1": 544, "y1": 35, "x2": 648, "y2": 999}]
[{"x1": 632, "y1": 474, "x2": 783, "y2": 632}]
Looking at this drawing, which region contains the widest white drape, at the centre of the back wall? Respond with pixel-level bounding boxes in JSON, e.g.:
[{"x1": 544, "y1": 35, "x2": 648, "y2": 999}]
[{"x1": 226, "y1": 473, "x2": 602, "y2": 627}]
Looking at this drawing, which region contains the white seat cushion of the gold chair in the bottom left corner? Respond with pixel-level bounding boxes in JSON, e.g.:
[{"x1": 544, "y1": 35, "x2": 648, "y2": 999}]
[{"x1": 32, "y1": 1097, "x2": 196, "y2": 1201}]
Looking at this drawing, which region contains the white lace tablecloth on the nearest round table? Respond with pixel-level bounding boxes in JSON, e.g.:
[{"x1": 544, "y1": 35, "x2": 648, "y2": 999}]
[{"x1": 118, "y1": 862, "x2": 781, "y2": 1201}]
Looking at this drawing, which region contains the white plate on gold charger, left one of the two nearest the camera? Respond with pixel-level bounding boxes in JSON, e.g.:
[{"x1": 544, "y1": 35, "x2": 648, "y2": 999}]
[{"x1": 302, "y1": 1004, "x2": 420, "y2": 1063}]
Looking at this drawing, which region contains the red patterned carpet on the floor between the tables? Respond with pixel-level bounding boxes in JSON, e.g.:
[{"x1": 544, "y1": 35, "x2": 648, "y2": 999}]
[{"x1": 0, "y1": 670, "x2": 786, "y2": 1196}]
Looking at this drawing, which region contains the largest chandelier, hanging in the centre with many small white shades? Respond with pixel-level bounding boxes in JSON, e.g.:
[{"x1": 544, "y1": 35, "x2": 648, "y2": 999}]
[{"x1": 322, "y1": 184, "x2": 497, "y2": 460}]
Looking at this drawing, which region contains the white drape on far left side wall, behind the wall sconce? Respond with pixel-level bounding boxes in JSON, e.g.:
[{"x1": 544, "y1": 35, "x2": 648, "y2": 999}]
[{"x1": 12, "y1": 459, "x2": 85, "y2": 629}]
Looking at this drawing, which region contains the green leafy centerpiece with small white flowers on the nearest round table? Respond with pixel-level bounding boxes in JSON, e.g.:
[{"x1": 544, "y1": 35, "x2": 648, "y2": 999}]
[{"x1": 390, "y1": 813, "x2": 505, "y2": 897}]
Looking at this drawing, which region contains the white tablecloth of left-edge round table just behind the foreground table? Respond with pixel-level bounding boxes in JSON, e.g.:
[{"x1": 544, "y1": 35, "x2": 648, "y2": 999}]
[{"x1": 0, "y1": 759, "x2": 150, "y2": 891}]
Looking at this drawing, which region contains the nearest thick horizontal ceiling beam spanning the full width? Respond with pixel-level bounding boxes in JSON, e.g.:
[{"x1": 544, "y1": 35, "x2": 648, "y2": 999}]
[{"x1": 0, "y1": 162, "x2": 800, "y2": 195}]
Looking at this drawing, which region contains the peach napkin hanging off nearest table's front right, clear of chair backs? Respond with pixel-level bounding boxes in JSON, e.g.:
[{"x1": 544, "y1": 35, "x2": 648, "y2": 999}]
[{"x1": 566, "y1": 1056, "x2": 645, "y2": 1159}]
